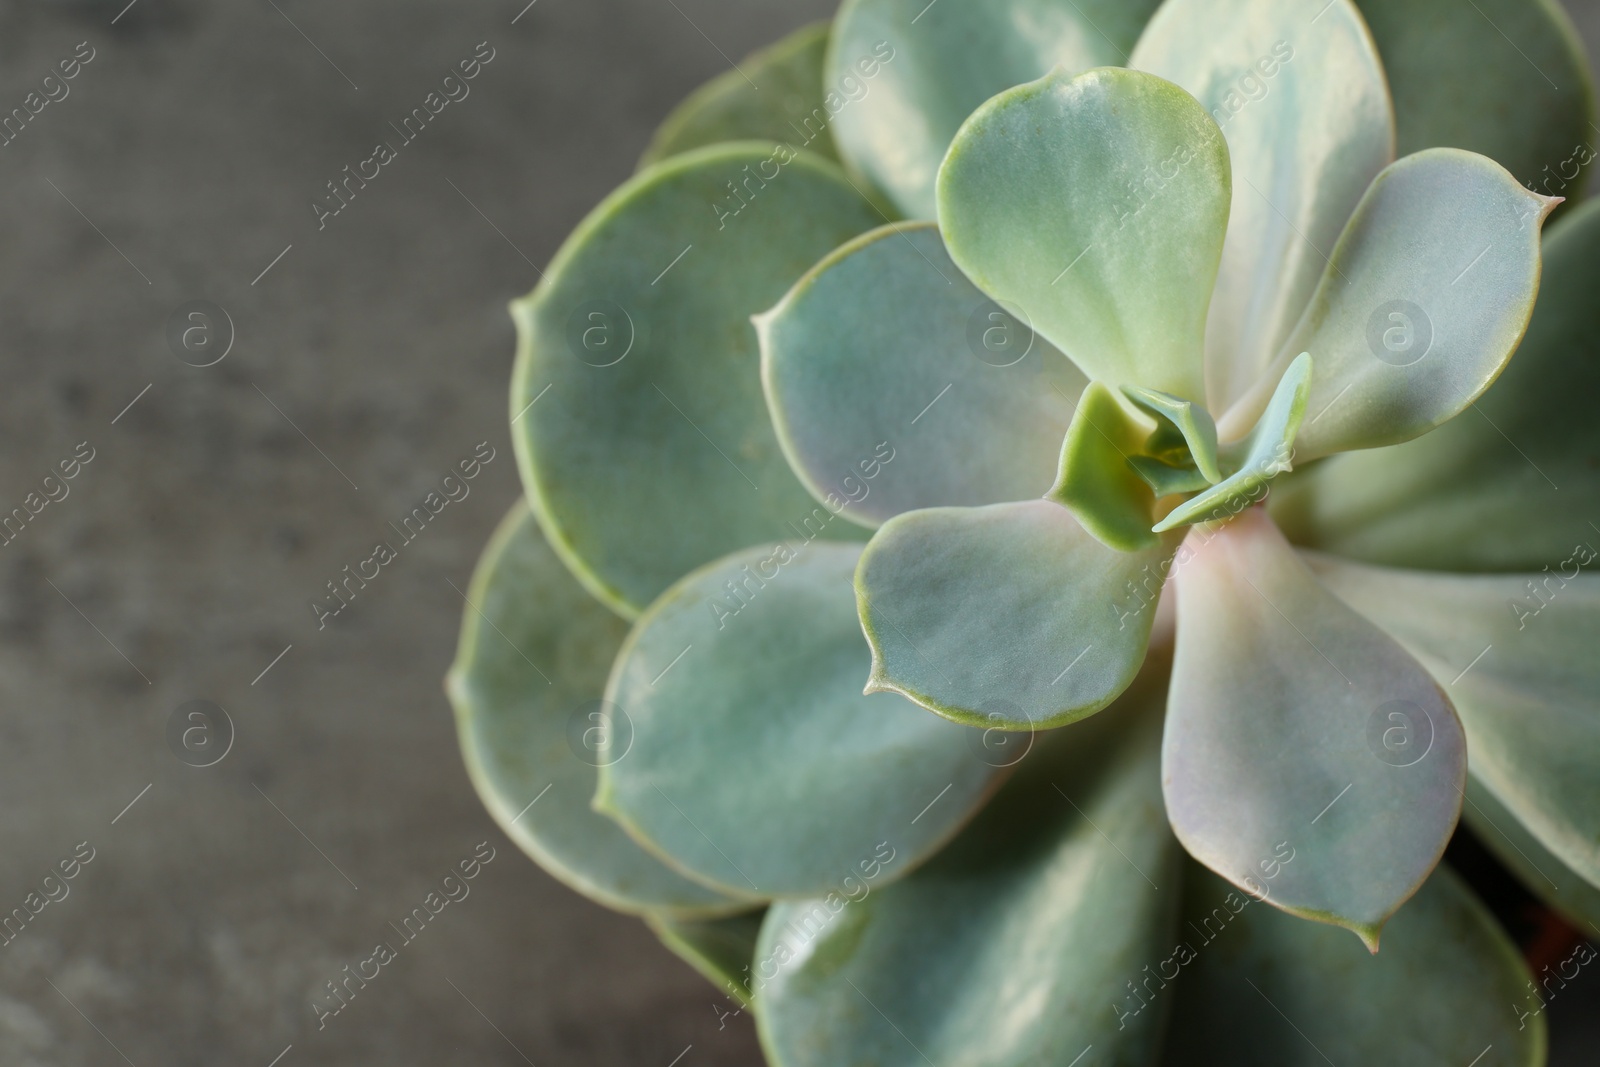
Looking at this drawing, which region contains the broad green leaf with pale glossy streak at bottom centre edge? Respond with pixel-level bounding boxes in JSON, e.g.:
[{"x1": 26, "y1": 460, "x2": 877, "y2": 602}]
[{"x1": 755, "y1": 673, "x2": 1181, "y2": 1067}]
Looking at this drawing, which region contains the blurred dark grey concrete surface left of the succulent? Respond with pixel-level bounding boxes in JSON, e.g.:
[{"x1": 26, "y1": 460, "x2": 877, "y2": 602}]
[{"x1": 0, "y1": 0, "x2": 1600, "y2": 1067}]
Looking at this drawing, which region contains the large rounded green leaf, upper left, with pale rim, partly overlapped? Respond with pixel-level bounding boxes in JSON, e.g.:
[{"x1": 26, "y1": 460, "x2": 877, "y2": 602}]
[{"x1": 510, "y1": 142, "x2": 878, "y2": 616}]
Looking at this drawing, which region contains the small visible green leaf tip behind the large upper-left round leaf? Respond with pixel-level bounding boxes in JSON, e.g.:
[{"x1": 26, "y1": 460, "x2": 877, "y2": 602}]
[{"x1": 638, "y1": 22, "x2": 838, "y2": 170}]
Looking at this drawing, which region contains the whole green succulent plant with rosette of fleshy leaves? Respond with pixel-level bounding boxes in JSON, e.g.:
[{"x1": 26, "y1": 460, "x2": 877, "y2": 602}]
[{"x1": 448, "y1": 0, "x2": 1600, "y2": 1067}]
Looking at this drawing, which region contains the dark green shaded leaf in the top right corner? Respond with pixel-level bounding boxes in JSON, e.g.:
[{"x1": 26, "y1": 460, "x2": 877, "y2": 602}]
[{"x1": 1360, "y1": 0, "x2": 1595, "y2": 206}]
